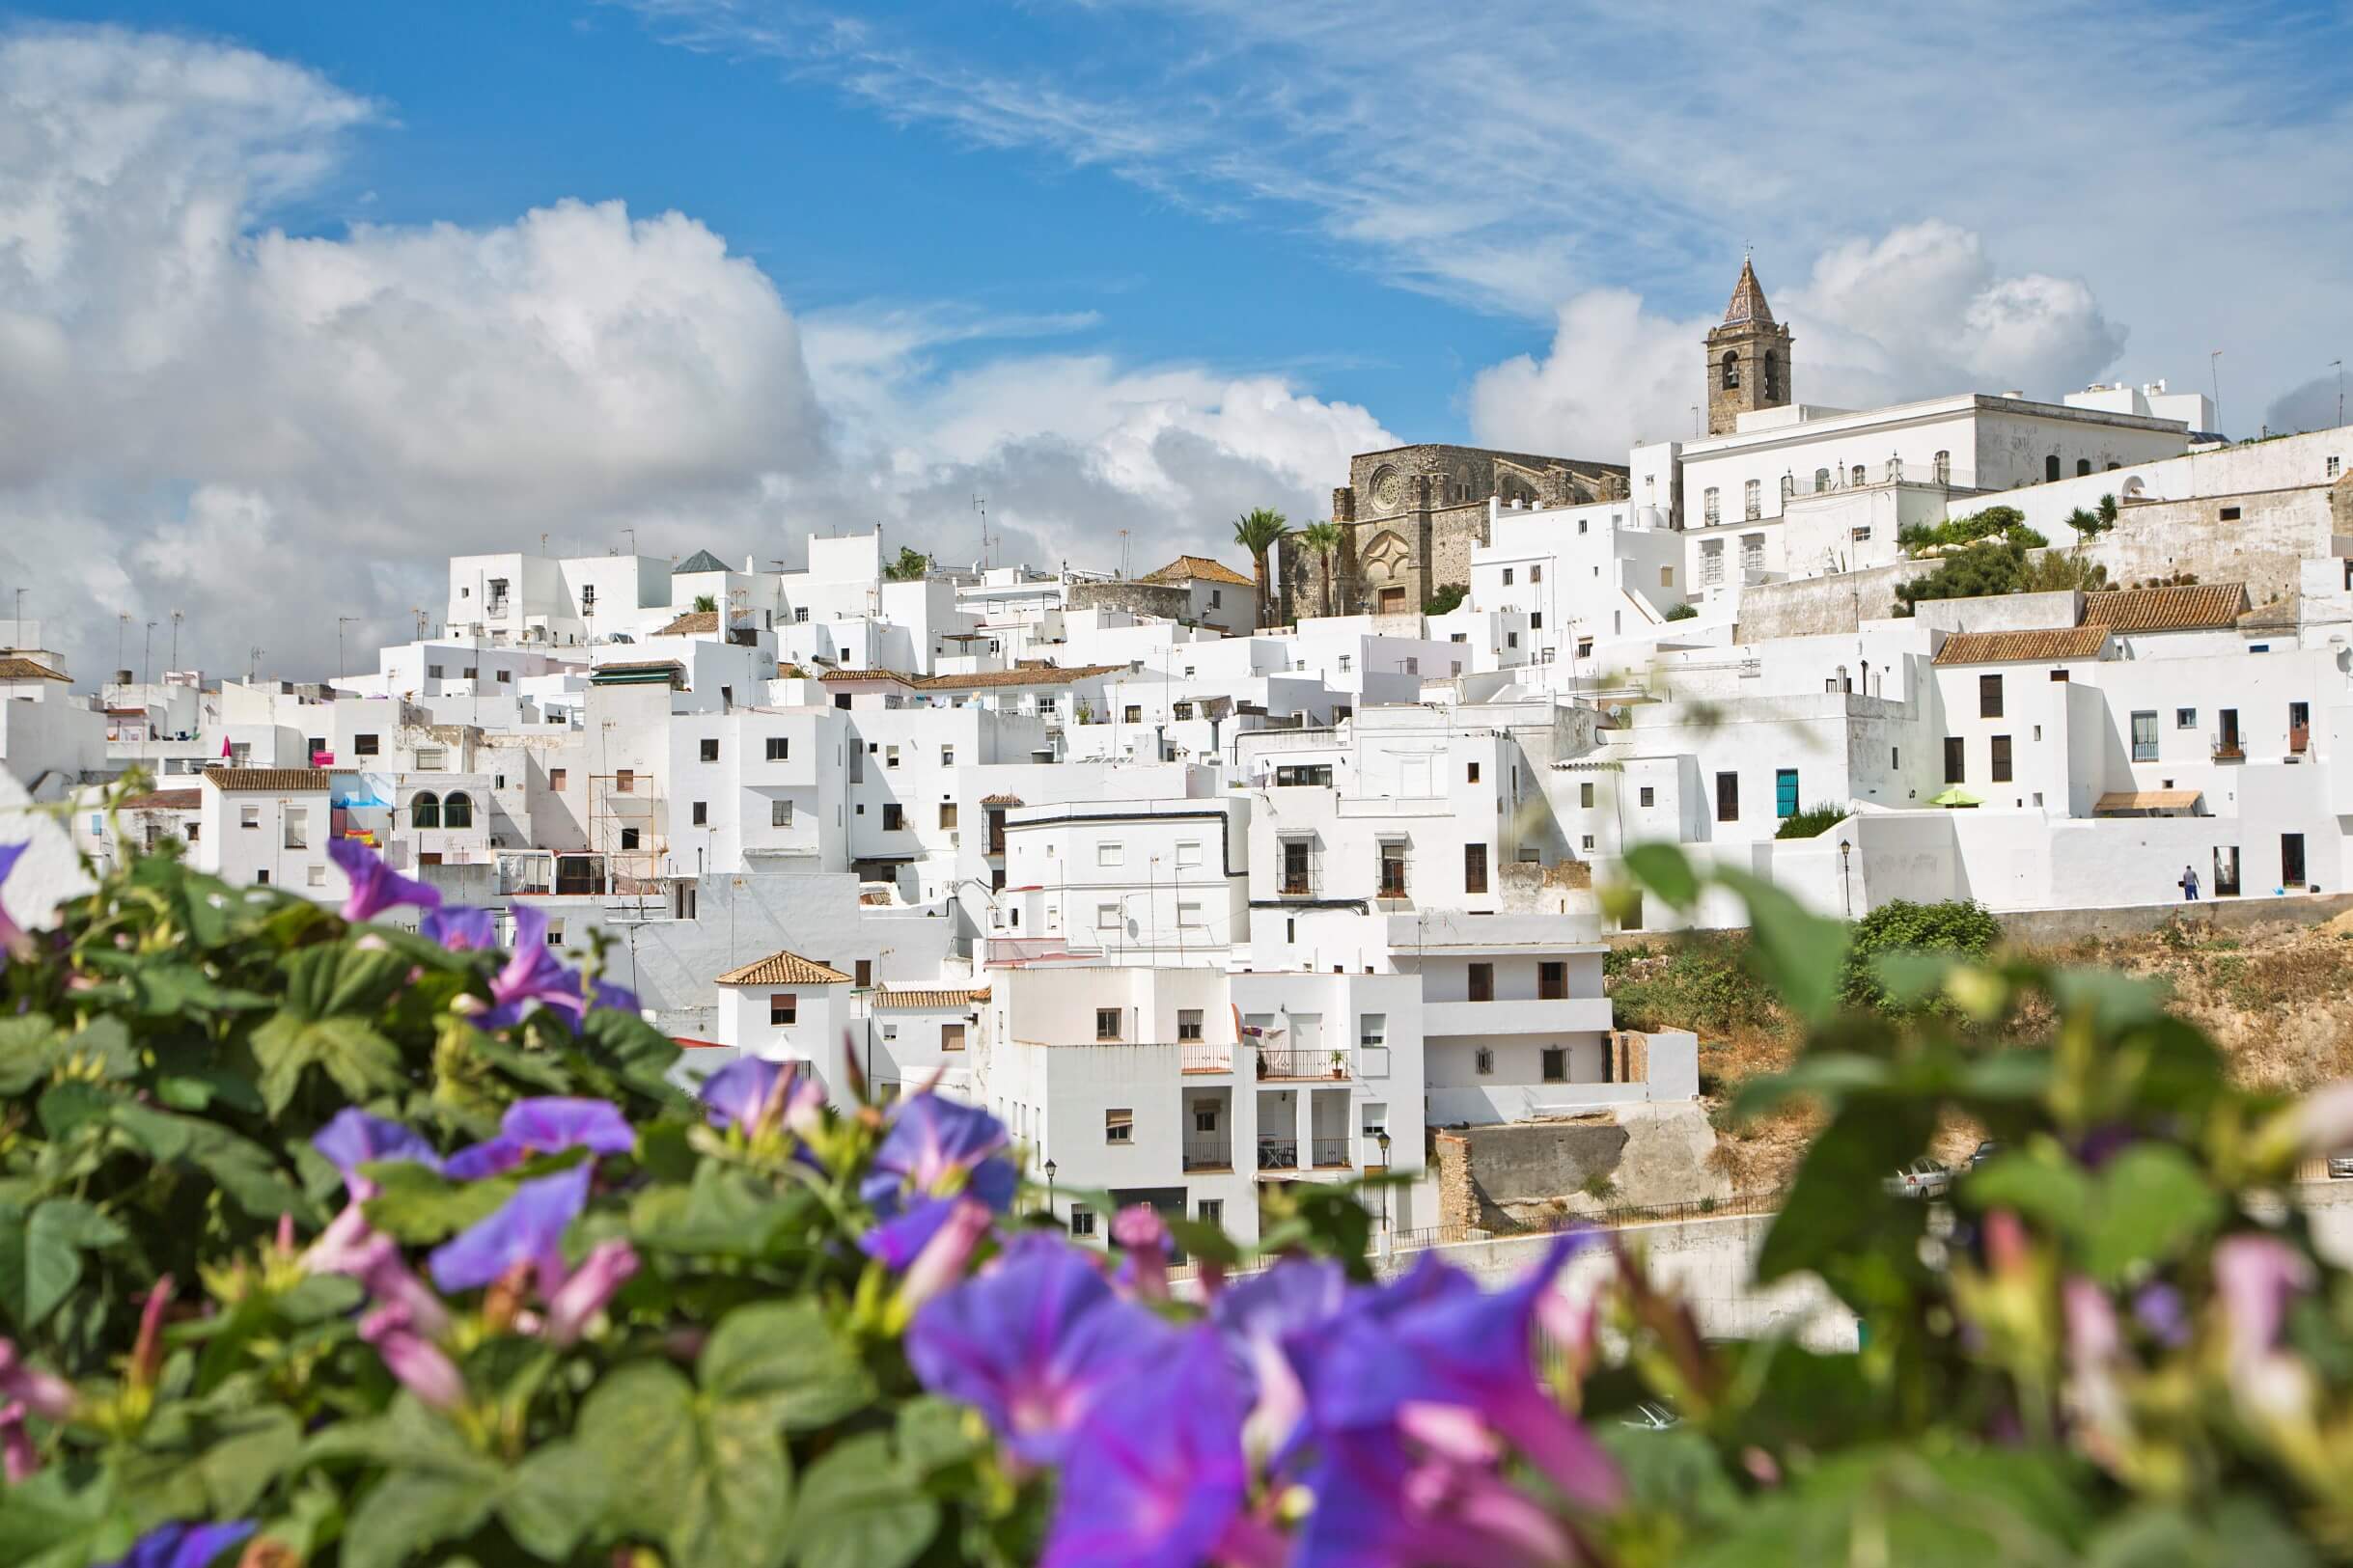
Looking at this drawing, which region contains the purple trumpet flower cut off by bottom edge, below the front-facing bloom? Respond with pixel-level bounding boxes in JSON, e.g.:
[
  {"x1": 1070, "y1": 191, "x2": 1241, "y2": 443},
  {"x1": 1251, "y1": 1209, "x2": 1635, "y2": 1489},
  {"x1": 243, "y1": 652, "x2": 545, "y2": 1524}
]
[{"x1": 1040, "y1": 1326, "x2": 1250, "y2": 1568}]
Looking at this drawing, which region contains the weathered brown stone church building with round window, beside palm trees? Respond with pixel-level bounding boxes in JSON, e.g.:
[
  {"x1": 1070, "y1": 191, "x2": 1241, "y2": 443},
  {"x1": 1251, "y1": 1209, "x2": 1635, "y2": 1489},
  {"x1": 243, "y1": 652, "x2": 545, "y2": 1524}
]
[{"x1": 1278, "y1": 444, "x2": 1626, "y2": 619}]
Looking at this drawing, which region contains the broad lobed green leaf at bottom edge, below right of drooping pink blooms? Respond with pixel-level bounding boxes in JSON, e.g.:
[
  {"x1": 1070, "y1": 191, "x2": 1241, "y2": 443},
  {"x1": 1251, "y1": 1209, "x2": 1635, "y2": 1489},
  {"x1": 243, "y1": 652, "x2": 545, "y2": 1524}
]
[{"x1": 576, "y1": 1362, "x2": 793, "y2": 1568}]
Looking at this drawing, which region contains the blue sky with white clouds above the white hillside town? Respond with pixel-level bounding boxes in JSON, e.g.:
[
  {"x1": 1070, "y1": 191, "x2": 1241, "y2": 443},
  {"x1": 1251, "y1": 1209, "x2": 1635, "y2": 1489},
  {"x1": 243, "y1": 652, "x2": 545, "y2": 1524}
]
[{"x1": 0, "y1": 0, "x2": 2353, "y2": 673}]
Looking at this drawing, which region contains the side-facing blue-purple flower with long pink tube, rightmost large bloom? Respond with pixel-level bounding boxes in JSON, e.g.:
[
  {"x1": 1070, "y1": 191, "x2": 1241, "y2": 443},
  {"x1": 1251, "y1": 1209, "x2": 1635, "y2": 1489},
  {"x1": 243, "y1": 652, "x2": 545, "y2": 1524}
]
[{"x1": 1306, "y1": 1232, "x2": 1621, "y2": 1509}]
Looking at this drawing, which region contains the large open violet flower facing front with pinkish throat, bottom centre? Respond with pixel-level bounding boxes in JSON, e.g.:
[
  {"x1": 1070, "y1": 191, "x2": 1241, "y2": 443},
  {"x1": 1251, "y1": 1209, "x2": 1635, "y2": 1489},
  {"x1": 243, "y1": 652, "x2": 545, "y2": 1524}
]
[{"x1": 906, "y1": 1232, "x2": 1176, "y2": 1465}]
